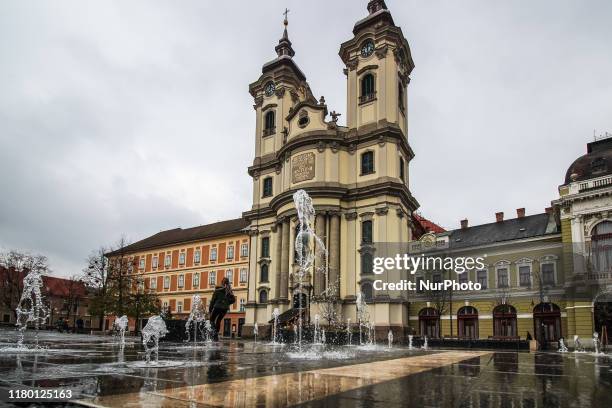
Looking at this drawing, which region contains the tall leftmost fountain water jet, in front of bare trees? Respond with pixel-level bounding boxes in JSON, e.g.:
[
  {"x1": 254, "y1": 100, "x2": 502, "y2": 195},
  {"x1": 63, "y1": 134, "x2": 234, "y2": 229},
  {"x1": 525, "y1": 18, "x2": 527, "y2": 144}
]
[{"x1": 15, "y1": 266, "x2": 49, "y2": 348}]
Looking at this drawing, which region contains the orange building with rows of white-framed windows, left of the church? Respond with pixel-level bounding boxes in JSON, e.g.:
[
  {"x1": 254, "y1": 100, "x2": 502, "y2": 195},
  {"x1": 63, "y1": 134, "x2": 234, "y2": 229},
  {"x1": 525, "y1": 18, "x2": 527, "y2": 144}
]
[{"x1": 110, "y1": 219, "x2": 249, "y2": 337}]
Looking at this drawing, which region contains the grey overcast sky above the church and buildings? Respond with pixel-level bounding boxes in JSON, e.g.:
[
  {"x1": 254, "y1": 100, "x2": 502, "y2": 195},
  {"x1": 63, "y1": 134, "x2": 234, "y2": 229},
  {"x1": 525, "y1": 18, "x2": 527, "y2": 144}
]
[{"x1": 0, "y1": 0, "x2": 612, "y2": 276}]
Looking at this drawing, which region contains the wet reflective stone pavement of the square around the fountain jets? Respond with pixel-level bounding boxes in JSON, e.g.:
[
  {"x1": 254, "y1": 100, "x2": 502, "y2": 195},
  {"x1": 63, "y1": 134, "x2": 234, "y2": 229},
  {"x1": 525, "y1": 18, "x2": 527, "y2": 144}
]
[{"x1": 0, "y1": 330, "x2": 612, "y2": 407}]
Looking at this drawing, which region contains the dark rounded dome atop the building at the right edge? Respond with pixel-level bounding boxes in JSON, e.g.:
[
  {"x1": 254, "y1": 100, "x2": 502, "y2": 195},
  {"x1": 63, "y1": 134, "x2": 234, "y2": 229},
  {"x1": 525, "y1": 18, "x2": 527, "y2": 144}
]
[{"x1": 565, "y1": 138, "x2": 612, "y2": 184}]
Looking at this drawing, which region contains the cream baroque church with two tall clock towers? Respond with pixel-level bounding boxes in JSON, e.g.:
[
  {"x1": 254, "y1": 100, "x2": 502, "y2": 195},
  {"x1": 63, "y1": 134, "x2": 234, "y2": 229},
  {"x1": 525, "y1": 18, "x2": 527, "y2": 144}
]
[{"x1": 243, "y1": 0, "x2": 419, "y2": 342}]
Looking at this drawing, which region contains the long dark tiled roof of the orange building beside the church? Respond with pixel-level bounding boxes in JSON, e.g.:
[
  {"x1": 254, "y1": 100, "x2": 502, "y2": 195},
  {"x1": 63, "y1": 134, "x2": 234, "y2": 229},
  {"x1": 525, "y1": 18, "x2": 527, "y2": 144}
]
[{"x1": 106, "y1": 218, "x2": 249, "y2": 256}]
